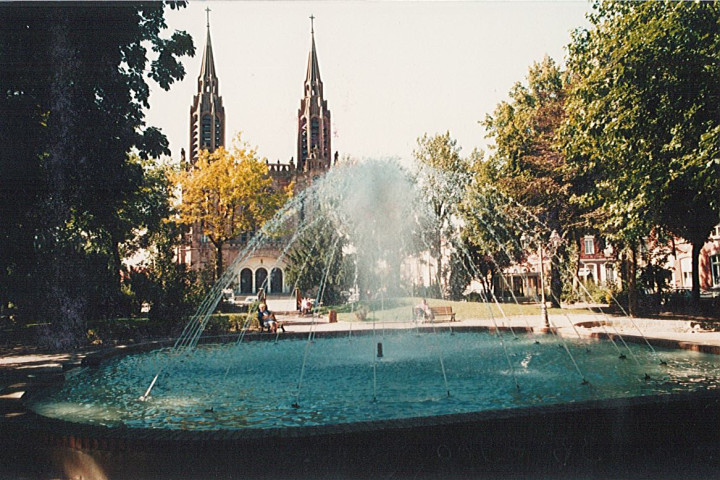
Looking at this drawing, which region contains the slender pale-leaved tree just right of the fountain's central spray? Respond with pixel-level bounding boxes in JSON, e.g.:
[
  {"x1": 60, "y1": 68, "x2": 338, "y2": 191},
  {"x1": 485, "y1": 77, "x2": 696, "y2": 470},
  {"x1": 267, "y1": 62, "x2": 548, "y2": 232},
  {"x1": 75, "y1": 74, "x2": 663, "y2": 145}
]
[{"x1": 413, "y1": 132, "x2": 470, "y2": 295}]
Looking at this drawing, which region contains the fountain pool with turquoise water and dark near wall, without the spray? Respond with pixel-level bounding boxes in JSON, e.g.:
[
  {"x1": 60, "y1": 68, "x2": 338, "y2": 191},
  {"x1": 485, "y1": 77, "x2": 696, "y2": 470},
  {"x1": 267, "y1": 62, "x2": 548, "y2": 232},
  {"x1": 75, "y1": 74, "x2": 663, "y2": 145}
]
[{"x1": 5, "y1": 327, "x2": 720, "y2": 480}]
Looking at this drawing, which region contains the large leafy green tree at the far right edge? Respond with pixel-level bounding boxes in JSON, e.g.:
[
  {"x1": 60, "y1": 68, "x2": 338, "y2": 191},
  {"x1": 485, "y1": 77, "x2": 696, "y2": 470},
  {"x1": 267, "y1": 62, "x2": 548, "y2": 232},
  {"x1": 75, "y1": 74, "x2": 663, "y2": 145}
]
[{"x1": 563, "y1": 2, "x2": 720, "y2": 307}]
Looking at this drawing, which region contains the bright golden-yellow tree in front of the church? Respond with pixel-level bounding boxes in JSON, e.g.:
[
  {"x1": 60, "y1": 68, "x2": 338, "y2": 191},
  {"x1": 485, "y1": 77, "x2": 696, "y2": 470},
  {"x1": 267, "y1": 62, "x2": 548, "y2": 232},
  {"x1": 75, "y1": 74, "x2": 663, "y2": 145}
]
[{"x1": 171, "y1": 135, "x2": 292, "y2": 279}]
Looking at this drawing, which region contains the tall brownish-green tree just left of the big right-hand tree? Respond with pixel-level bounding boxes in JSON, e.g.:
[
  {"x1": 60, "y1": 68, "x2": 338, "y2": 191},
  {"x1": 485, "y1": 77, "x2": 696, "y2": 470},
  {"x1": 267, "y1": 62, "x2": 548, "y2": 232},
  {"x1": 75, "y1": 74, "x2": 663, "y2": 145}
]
[{"x1": 483, "y1": 57, "x2": 578, "y2": 306}]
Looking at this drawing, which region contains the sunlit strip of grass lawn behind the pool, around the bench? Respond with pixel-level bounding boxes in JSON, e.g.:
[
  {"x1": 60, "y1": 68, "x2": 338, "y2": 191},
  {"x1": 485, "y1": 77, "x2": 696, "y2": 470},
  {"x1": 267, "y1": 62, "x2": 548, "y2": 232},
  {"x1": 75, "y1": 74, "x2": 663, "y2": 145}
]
[{"x1": 336, "y1": 297, "x2": 572, "y2": 322}]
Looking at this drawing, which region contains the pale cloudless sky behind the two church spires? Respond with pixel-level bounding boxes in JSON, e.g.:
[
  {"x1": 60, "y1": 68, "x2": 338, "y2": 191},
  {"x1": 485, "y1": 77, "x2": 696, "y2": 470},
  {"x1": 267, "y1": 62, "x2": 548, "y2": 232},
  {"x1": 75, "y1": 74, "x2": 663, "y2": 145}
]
[{"x1": 147, "y1": 0, "x2": 591, "y2": 163}]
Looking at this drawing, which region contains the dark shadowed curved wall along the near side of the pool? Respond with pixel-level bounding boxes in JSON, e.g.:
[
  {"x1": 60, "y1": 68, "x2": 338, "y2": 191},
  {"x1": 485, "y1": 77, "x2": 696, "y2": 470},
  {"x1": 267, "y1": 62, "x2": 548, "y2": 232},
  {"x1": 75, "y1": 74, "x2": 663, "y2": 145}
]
[{"x1": 8, "y1": 391, "x2": 720, "y2": 478}]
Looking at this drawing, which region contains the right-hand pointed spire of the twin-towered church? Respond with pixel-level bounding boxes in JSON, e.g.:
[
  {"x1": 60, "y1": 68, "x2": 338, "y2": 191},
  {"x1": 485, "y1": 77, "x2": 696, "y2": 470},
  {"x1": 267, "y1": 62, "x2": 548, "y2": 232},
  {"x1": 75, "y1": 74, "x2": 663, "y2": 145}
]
[{"x1": 297, "y1": 15, "x2": 332, "y2": 175}]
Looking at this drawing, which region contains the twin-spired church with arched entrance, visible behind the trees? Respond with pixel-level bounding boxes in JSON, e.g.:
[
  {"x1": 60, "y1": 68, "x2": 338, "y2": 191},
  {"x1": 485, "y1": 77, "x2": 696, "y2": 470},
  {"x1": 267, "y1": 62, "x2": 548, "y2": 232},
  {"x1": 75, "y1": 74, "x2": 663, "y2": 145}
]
[{"x1": 178, "y1": 17, "x2": 337, "y2": 295}]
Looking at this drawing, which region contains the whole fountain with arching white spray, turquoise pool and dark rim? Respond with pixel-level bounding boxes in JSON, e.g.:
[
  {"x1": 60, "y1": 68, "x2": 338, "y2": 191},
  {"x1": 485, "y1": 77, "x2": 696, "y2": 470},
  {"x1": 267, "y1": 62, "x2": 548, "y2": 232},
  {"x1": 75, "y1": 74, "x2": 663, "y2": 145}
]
[{"x1": 15, "y1": 160, "x2": 720, "y2": 478}]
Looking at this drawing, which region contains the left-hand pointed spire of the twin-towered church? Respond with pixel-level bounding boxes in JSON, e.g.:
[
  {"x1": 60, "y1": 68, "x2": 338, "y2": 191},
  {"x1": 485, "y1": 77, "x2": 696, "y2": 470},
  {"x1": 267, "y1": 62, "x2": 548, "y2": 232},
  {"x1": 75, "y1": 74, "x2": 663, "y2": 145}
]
[{"x1": 189, "y1": 8, "x2": 225, "y2": 165}]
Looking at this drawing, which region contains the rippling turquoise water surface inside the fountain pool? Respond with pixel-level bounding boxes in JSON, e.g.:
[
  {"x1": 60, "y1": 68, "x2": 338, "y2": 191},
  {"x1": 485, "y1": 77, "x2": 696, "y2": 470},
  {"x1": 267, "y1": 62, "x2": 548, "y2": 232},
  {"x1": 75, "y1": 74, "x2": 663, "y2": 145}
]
[{"x1": 30, "y1": 331, "x2": 720, "y2": 430}]
